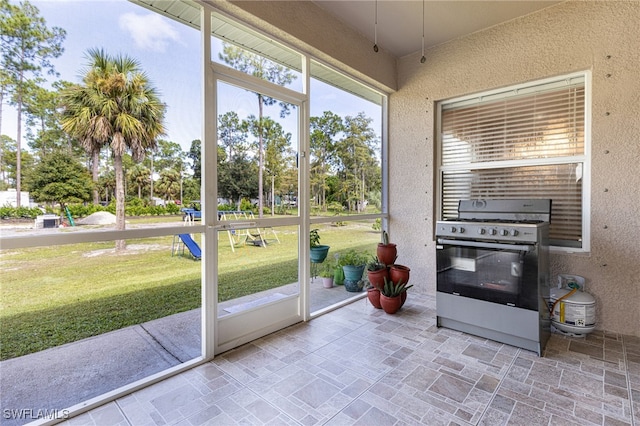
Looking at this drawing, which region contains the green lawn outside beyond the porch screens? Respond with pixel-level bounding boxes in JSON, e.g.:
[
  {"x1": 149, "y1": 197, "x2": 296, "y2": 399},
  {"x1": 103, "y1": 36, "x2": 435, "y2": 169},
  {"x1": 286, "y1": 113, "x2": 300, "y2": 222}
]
[{"x1": 0, "y1": 218, "x2": 379, "y2": 360}]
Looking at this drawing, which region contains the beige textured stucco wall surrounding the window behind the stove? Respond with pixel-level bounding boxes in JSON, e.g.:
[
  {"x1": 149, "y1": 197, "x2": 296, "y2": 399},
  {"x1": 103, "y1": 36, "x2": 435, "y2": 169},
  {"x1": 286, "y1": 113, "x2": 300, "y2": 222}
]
[{"x1": 389, "y1": 1, "x2": 640, "y2": 336}]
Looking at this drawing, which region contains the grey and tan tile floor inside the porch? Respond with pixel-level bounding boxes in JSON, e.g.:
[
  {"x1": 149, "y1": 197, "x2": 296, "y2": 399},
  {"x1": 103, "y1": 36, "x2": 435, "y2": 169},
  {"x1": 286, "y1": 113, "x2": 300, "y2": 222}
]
[{"x1": 66, "y1": 293, "x2": 640, "y2": 426}]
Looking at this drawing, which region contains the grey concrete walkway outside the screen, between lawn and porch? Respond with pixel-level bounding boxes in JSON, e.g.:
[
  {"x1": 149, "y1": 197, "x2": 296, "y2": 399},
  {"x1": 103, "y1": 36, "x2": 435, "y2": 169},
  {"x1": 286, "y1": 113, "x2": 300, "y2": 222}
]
[{"x1": 0, "y1": 280, "x2": 361, "y2": 426}]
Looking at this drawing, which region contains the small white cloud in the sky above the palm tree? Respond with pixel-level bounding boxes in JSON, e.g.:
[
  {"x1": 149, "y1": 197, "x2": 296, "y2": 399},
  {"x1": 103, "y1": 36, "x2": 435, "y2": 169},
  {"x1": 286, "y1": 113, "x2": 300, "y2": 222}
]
[{"x1": 119, "y1": 13, "x2": 179, "y2": 52}]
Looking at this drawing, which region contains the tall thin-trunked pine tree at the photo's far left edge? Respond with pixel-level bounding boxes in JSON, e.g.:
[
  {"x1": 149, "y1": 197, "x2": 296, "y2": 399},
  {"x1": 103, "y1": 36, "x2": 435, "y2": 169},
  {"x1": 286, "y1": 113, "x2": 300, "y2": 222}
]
[{"x1": 0, "y1": 0, "x2": 66, "y2": 207}]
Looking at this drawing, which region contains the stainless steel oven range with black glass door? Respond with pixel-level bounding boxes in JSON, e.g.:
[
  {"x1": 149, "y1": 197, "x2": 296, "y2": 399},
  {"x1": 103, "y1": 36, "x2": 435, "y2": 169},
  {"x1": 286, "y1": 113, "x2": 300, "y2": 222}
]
[{"x1": 435, "y1": 199, "x2": 551, "y2": 356}]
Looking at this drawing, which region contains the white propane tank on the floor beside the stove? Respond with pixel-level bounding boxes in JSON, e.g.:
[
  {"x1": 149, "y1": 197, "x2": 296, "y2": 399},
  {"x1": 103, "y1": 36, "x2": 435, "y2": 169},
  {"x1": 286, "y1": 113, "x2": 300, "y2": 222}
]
[{"x1": 549, "y1": 274, "x2": 596, "y2": 337}]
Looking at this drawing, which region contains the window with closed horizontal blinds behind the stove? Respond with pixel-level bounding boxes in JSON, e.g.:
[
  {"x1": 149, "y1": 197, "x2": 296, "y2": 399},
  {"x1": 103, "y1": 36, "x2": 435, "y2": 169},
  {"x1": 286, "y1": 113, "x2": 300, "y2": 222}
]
[{"x1": 438, "y1": 74, "x2": 588, "y2": 250}]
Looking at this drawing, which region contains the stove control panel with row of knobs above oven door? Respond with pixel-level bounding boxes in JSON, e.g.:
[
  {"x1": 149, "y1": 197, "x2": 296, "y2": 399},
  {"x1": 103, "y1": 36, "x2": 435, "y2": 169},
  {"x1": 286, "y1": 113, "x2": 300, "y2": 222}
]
[{"x1": 436, "y1": 221, "x2": 548, "y2": 243}]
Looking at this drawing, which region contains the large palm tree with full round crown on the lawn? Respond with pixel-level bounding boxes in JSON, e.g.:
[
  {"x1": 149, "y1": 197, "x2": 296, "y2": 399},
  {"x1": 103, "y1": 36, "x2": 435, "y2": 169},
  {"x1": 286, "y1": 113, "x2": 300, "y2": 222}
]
[{"x1": 62, "y1": 49, "x2": 165, "y2": 251}]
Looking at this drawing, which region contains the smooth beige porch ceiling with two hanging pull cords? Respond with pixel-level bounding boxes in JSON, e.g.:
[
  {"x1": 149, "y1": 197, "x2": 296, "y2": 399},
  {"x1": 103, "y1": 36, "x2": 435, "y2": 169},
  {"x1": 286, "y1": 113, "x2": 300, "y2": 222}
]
[{"x1": 313, "y1": 0, "x2": 560, "y2": 57}]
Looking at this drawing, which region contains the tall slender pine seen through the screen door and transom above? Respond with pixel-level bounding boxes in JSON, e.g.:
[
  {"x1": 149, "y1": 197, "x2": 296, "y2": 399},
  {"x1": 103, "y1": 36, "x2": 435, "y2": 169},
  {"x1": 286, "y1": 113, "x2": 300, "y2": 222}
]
[{"x1": 219, "y1": 43, "x2": 296, "y2": 217}]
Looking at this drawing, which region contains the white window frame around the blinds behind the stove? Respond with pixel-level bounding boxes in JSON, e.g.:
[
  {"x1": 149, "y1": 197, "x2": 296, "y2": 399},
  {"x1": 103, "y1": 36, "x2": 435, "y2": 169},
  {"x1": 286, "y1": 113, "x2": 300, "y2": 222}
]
[{"x1": 434, "y1": 70, "x2": 592, "y2": 253}]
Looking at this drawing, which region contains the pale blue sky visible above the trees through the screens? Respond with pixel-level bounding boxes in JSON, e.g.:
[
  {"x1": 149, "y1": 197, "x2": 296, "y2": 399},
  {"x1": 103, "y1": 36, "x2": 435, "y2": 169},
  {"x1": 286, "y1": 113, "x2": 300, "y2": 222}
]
[{"x1": 0, "y1": 0, "x2": 380, "y2": 151}]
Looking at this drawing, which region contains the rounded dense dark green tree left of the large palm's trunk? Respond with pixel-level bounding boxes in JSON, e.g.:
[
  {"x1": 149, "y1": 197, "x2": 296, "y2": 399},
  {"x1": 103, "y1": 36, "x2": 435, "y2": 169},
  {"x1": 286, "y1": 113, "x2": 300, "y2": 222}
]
[{"x1": 30, "y1": 151, "x2": 93, "y2": 210}]
